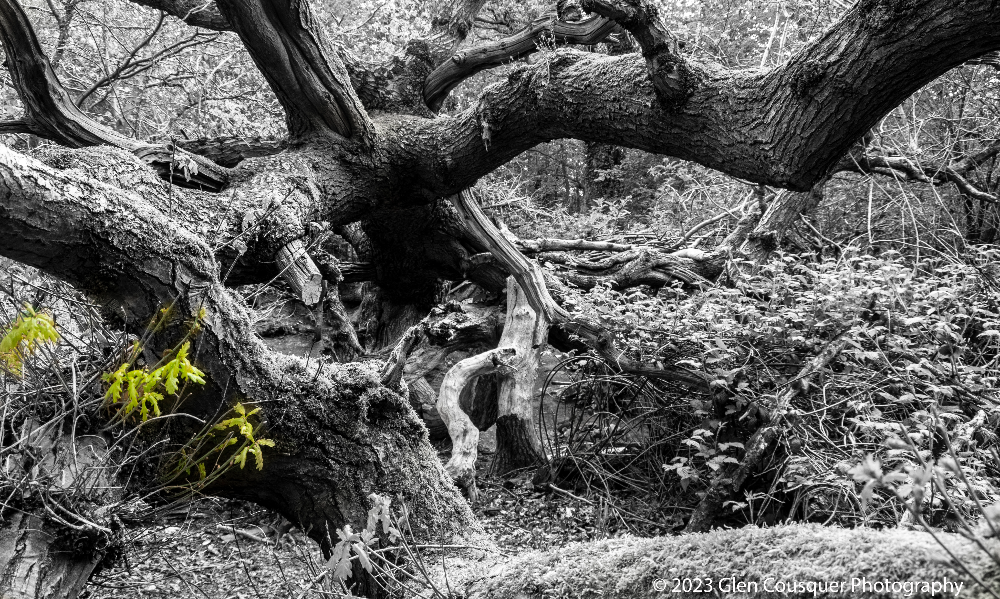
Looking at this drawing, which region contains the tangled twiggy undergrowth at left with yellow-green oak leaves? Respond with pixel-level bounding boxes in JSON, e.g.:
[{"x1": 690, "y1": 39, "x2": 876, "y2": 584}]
[{"x1": 0, "y1": 263, "x2": 273, "y2": 571}]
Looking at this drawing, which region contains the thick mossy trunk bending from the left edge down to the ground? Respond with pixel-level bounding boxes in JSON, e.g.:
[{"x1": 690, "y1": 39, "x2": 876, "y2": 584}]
[{"x1": 0, "y1": 148, "x2": 481, "y2": 568}]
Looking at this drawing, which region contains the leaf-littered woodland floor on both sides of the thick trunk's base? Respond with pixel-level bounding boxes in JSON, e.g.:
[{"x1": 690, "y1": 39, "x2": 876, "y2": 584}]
[{"x1": 83, "y1": 430, "x2": 681, "y2": 599}]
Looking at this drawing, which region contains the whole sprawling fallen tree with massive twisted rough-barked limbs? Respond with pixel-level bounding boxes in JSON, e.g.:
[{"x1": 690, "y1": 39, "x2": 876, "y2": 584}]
[{"x1": 0, "y1": 0, "x2": 1000, "y2": 596}]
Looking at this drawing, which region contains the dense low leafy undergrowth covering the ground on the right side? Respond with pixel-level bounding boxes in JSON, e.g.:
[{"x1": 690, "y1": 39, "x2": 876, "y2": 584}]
[{"x1": 549, "y1": 249, "x2": 1000, "y2": 531}]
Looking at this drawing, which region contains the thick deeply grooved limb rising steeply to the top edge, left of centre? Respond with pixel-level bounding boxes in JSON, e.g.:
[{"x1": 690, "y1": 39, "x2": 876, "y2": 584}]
[{"x1": 218, "y1": 0, "x2": 374, "y2": 143}]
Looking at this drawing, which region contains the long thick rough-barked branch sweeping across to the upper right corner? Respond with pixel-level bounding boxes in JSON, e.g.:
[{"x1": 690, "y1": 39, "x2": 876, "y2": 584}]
[{"x1": 397, "y1": 0, "x2": 1000, "y2": 195}]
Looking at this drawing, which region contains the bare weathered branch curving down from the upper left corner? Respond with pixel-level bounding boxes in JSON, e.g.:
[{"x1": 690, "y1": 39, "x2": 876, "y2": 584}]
[{"x1": 0, "y1": 0, "x2": 229, "y2": 191}]
